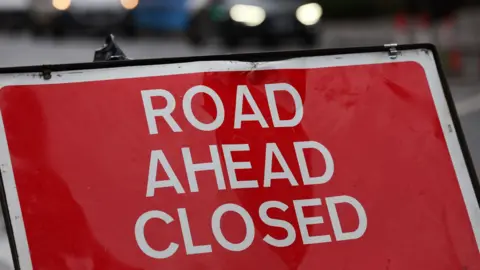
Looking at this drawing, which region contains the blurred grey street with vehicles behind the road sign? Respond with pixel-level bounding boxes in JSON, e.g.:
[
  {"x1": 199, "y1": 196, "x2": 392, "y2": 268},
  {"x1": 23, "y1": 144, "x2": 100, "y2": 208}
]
[{"x1": 0, "y1": 0, "x2": 480, "y2": 270}]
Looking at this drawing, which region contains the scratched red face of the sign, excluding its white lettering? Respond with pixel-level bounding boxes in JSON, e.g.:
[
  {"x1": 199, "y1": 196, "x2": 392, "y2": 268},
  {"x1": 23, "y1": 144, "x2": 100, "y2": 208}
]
[{"x1": 0, "y1": 62, "x2": 480, "y2": 270}]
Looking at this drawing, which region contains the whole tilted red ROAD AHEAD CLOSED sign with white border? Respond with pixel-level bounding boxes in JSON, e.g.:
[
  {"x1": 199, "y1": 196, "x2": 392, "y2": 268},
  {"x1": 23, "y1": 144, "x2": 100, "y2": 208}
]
[{"x1": 0, "y1": 45, "x2": 480, "y2": 270}]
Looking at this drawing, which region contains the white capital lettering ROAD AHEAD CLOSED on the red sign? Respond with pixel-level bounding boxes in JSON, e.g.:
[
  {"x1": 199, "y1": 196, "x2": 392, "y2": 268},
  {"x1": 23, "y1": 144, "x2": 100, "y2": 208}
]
[{"x1": 135, "y1": 83, "x2": 367, "y2": 259}]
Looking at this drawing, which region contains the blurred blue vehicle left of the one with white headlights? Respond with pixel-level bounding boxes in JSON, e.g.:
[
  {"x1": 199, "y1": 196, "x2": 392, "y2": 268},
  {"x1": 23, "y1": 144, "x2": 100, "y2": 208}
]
[{"x1": 133, "y1": 0, "x2": 188, "y2": 33}]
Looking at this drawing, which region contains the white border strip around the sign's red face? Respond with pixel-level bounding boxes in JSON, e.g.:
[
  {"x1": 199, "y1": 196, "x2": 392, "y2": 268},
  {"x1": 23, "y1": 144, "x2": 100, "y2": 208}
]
[{"x1": 0, "y1": 49, "x2": 480, "y2": 270}]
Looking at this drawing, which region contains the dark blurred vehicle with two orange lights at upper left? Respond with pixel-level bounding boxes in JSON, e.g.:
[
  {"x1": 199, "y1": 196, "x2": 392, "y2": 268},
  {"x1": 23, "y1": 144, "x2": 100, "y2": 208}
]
[{"x1": 29, "y1": 0, "x2": 139, "y2": 37}]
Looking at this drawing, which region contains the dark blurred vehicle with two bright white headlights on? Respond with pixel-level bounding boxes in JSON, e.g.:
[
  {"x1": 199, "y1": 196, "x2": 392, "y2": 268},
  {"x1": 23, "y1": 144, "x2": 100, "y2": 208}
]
[{"x1": 206, "y1": 0, "x2": 323, "y2": 47}]
